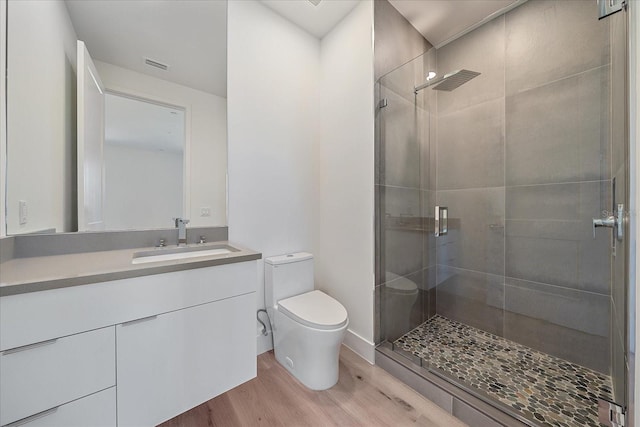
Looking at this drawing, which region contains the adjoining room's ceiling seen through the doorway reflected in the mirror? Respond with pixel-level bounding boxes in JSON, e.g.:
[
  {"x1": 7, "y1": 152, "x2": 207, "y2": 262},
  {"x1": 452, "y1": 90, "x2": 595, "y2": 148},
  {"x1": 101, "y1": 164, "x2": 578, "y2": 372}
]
[{"x1": 104, "y1": 93, "x2": 185, "y2": 153}]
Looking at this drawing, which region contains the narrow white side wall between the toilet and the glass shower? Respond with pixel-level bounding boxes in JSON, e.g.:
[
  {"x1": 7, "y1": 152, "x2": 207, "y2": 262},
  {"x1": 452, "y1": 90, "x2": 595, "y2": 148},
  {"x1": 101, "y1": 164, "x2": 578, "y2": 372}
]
[{"x1": 313, "y1": 1, "x2": 375, "y2": 363}]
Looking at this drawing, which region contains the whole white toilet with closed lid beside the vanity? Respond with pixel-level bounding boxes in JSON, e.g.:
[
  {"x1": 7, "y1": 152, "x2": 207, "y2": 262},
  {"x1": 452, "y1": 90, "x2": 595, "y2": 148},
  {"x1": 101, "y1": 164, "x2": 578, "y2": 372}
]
[{"x1": 265, "y1": 252, "x2": 349, "y2": 390}]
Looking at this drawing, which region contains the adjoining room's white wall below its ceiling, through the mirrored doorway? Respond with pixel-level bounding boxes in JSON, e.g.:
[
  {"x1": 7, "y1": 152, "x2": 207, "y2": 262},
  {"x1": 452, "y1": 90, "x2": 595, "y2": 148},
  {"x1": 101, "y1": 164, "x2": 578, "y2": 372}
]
[{"x1": 104, "y1": 143, "x2": 183, "y2": 230}]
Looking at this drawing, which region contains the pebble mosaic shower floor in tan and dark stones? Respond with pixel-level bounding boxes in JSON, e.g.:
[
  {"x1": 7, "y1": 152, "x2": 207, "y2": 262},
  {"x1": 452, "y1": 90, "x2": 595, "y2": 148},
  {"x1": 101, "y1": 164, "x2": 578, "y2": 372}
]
[{"x1": 393, "y1": 315, "x2": 612, "y2": 427}]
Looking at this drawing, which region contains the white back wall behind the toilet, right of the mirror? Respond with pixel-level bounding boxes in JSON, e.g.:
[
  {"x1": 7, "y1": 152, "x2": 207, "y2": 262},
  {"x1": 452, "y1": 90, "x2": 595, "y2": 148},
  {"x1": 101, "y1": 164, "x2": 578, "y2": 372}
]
[{"x1": 227, "y1": 1, "x2": 320, "y2": 351}]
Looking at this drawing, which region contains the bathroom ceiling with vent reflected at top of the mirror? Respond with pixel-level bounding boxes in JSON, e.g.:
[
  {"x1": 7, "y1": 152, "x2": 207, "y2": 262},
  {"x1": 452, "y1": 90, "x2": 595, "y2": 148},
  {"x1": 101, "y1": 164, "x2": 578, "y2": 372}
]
[{"x1": 65, "y1": 0, "x2": 227, "y2": 98}]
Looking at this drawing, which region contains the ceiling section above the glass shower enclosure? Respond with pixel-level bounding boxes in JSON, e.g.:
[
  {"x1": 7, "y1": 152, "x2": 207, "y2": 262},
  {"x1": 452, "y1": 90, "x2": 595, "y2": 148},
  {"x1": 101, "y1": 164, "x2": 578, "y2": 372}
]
[{"x1": 389, "y1": 0, "x2": 523, "y2": 47}]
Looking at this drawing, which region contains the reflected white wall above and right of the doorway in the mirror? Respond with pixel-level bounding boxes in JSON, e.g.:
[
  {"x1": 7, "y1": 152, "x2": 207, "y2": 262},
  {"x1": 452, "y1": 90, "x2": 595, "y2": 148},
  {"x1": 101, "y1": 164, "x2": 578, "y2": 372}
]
[{"x1": 94, "y1": 61, "x2": 227, "y2": 228}]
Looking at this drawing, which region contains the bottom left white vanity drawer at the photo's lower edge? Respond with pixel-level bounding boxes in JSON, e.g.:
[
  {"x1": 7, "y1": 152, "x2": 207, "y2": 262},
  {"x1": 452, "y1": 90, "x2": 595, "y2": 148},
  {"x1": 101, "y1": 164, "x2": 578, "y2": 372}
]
[{"x1": 1, "y1": 387, "x2": 116, "y2": 427}]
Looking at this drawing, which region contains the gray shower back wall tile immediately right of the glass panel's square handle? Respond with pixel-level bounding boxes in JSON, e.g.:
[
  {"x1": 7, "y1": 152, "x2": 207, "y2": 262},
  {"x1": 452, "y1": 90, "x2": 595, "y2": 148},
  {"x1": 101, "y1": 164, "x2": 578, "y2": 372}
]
[{"x1": 436, "y1": 188, "x2": 504, "y2": 275}]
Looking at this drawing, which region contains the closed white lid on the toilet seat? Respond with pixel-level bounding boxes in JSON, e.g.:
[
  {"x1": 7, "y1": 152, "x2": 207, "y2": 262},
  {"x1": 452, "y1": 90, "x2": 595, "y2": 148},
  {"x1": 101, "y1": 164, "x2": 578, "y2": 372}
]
[{"x1": 278, "y1": 291, "x2": 347, "y2": 329}]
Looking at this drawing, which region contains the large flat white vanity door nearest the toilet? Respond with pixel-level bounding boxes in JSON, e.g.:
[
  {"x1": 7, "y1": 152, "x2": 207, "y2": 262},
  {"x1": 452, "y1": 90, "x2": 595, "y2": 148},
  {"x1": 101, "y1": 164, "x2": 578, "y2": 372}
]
[{"x1": 116, "y1": 294, "x2": 256, "y2": 427}]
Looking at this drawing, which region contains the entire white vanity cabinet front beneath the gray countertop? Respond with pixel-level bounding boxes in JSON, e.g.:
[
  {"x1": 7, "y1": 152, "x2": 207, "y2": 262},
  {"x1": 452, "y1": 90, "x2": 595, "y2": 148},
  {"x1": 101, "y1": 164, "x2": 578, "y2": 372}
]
[{"x1": 0, "y1": 261, "x2": 257, "y2": 427}]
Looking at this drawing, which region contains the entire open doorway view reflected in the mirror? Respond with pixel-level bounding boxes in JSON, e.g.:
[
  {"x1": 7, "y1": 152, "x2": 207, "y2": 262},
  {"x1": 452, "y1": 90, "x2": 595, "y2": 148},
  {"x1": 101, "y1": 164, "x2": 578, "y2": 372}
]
[{"x1": 104, "y1": 93, "x2": 185, "y2": 230}]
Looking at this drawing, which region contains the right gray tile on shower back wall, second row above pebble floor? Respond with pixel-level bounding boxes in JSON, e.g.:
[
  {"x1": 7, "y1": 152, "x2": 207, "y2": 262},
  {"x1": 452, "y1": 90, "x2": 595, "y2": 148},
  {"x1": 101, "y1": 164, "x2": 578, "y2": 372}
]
[{"x1": 504, "y1": 277, "x2": 610, "y2": 337}]
